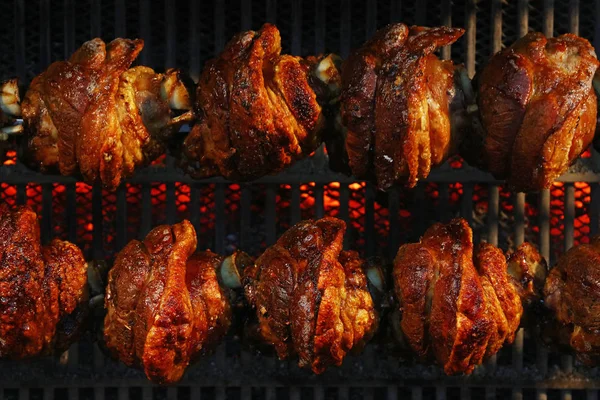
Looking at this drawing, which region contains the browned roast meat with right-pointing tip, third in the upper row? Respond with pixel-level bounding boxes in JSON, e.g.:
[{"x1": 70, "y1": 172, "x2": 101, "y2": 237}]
[{"x1": 341, "y1": 23, "x2": 464, "y2": 189}]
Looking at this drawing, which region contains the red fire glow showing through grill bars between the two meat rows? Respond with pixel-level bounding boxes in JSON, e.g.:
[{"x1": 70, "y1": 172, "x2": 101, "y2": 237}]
[{"x1": 0, "y1": 150, "x2": 591, "y2": 260}]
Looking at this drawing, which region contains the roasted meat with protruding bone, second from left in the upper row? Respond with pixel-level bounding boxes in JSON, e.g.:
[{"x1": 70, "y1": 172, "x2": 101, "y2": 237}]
[{"x1": 183, "y1": 24, "x2": 339, "y2": 181}]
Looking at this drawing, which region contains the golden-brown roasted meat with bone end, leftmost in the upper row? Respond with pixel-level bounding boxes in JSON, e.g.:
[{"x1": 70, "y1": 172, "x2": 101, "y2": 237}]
[{"x1": 22, "y1": 39, "x2": 191, "y2": 189}]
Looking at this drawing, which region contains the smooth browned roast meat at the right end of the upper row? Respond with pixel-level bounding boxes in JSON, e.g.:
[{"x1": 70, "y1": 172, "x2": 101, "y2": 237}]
[{"x1": 472, "y1": 33, "x2": 598, "y2": 191}]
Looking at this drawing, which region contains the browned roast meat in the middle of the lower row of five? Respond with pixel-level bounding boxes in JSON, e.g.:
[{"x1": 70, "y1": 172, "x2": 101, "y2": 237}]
[{"x1": 243, "y1": 218, "x2": 378, "y2": 373}]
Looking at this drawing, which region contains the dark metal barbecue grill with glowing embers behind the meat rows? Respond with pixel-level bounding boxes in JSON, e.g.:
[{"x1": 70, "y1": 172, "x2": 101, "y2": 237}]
[{"x1": 0, "y1": 0, "x2": 600, "y2": 400}]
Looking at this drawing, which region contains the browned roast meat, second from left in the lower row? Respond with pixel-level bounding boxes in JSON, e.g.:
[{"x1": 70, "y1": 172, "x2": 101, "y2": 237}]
[{"x1": 104, "y1": 221, "x2": 231, "y2": 384}]
